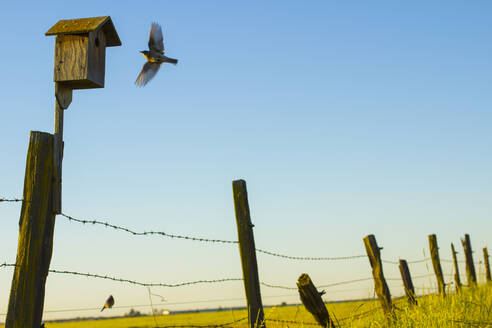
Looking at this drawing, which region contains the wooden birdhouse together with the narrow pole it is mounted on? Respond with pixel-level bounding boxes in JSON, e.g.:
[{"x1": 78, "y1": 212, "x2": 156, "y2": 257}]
[{"x1": 45, "y1": 16, "x2": 121, "y2": 214}]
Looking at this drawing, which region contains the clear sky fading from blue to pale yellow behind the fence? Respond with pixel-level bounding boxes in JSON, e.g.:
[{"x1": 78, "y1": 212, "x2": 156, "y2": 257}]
[{"x1": 0, "y1": 1, "x2": 492, "y2": 321}]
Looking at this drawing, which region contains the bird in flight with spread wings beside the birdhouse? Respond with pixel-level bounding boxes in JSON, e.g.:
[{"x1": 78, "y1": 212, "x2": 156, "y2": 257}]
[{"x1": 135, "y1": 23, "x2": 178, "y2": 87}]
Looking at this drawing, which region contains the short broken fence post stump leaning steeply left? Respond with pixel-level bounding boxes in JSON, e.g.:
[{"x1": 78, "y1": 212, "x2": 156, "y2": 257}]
[{"x1": 297, "y1": 273, "x2": 335, "y2": 328}]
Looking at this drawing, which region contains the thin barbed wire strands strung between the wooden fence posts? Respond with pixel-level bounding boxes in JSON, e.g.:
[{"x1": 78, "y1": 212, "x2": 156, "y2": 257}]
[{"x1": 0, "y1": 198, "x2": 490, "y2": 328}]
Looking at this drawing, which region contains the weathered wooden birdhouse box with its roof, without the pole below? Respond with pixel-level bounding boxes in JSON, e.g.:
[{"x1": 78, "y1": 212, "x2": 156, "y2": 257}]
[{"x1": 45, "y1": 16, "x2": 121, "y2": 89}]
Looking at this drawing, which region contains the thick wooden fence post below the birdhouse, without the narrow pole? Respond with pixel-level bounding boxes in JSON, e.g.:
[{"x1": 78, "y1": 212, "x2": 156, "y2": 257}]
[{"x1": 5, "y1": 131, "x2": 55, "y2": 328}]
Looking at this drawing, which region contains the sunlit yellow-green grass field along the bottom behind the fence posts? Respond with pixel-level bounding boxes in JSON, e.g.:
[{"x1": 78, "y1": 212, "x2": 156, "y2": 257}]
[{"x1": 2, "y1": 284, "x2": 492, "y2": 328}]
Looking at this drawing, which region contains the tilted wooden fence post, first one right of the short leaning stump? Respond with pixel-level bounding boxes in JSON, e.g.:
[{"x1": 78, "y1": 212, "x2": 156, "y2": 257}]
[{"x1": 364, "y1": 235, "x2": 392, "y2": 314}]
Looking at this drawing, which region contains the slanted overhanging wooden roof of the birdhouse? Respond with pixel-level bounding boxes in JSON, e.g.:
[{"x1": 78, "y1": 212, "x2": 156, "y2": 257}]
[{"x1": 45, "y1": 16, "x2": 121, "y2": 47}]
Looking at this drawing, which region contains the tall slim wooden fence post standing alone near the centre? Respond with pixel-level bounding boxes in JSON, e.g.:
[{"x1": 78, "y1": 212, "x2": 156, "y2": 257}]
[{"x1": 232, "y1": 180, "x2": 265, "y2": 328}]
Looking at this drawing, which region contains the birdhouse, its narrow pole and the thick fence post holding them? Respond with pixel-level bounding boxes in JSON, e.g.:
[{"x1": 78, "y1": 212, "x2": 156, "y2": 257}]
[{"x1": 5, "y1": 16, "x2": 121, "y2": 328}]
